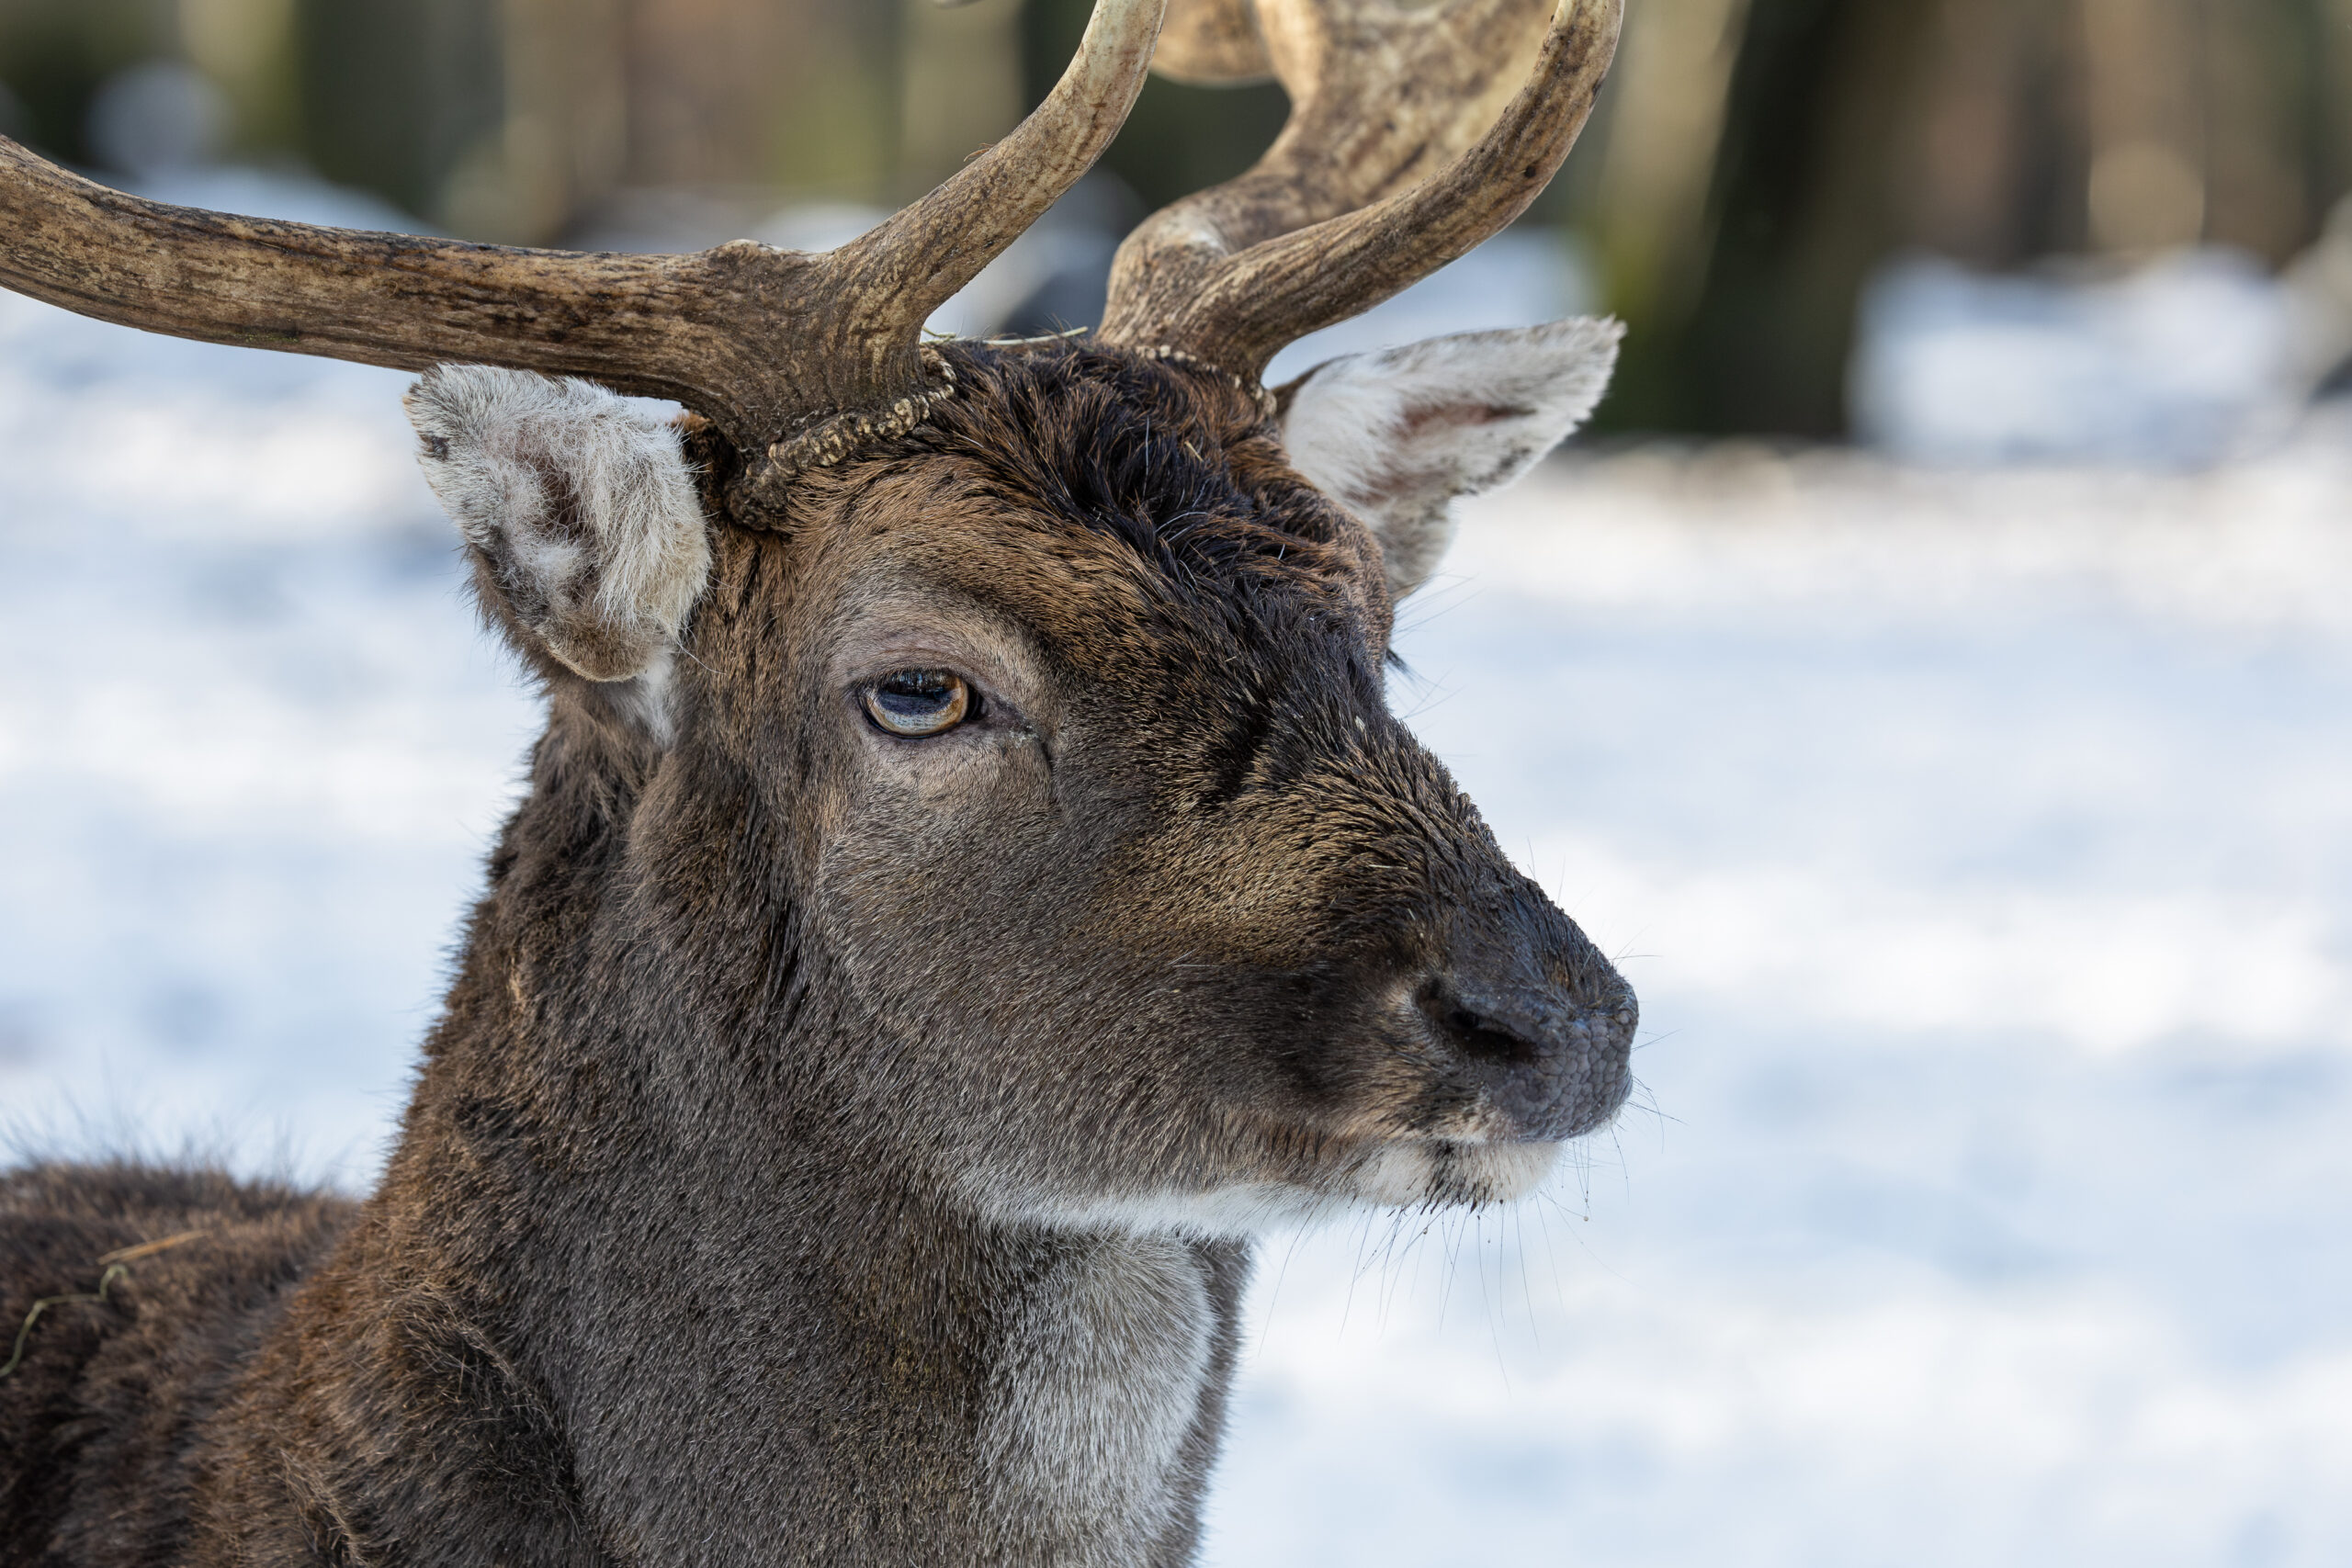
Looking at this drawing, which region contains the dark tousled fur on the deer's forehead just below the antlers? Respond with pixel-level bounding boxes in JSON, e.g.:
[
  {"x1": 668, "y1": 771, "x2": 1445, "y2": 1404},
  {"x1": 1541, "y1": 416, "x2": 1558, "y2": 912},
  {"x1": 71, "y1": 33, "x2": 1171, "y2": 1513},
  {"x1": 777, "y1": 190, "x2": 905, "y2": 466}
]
[{"x1": 808, "y1": 344, "x2": 1390, "y2": 649}]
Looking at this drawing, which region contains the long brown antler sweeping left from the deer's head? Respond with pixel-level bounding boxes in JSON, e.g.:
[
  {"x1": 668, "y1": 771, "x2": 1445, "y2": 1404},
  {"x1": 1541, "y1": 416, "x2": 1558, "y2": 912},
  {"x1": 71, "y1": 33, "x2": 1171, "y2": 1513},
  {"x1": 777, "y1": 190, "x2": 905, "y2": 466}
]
[{"x1": 0, "y1": 0, "x2": 1164, "y2": 449}]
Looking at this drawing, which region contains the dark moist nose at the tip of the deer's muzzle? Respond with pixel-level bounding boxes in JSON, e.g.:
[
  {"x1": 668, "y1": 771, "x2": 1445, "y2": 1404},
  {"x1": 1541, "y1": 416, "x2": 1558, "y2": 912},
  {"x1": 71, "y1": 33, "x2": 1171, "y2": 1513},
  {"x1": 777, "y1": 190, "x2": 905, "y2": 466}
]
[{"x1": 1419, "y1": 966, "x2": 1639, "y2": 1143}]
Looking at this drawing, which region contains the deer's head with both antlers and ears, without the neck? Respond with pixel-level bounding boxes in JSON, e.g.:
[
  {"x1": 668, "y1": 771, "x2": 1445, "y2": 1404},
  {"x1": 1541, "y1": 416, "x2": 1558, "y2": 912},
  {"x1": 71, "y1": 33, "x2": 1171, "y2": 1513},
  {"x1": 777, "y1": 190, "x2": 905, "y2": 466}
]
[{"x1": 0, "y1": 0, "x2": 1634, "y2": 1235}]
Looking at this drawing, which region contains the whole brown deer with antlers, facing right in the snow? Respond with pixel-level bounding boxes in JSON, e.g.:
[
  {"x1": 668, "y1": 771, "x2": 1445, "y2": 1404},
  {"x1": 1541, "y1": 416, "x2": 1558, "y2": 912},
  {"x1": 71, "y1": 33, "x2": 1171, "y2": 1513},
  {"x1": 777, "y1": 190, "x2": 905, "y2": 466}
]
[{"x1": 0, "y1": 0, "x2": 1637, "y2": 1568}]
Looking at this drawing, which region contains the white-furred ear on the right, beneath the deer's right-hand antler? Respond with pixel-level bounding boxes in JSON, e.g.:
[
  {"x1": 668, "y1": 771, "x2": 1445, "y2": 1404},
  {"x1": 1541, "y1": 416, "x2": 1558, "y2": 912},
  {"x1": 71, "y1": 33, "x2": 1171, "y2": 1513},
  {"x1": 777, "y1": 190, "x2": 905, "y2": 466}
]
[{"x1": 1275, "y1": 317, "x2": 1625, "y2": 600}]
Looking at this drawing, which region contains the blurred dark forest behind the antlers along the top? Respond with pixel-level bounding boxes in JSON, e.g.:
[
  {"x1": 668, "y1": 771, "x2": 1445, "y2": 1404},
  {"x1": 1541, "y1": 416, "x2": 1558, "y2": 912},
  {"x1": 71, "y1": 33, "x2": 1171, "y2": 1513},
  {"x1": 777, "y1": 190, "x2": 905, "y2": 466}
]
[{"x1": 0, "y1": 0, "x2": 2352, "y2": 437}]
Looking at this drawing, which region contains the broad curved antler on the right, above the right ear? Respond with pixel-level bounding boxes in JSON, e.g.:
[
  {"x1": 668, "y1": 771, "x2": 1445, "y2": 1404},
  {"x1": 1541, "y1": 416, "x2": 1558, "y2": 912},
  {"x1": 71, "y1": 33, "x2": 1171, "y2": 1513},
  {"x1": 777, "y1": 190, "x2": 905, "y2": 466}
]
[{"x1": 1101, "y1": 0, "x2": 1623, "y2": 378}]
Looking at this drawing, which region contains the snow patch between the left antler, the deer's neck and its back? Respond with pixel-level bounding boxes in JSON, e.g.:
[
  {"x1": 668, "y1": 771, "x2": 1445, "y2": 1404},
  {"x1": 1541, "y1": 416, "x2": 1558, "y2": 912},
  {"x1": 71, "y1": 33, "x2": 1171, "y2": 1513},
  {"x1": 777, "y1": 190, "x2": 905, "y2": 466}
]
[{"x1": 0, "y1": 294, "x2": 532, "y2": 1180}]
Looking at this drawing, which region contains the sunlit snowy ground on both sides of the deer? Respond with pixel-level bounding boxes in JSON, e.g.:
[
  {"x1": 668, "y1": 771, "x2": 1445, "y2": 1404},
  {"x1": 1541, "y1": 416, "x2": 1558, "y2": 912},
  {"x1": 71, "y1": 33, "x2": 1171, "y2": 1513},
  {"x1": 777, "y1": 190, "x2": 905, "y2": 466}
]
[{"x1": 0, "y1": 285, "x2": 2352, "y2": 1568}]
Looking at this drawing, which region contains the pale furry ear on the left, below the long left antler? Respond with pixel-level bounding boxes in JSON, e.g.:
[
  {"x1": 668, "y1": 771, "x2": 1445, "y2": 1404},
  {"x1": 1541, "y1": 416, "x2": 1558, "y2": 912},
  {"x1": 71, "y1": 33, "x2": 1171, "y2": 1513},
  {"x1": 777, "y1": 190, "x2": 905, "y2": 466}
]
[{"x1": 407, "y1": 365, "x2": 710, "y2": 682}]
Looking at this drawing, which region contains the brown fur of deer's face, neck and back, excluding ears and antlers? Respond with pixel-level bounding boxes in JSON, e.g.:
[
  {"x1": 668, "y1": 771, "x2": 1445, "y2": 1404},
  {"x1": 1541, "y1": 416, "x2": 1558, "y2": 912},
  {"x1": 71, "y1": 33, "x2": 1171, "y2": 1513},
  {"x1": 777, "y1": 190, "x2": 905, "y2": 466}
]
[{"x1": 0, "y1": 345, "x2": 1633, "y2": 1568}]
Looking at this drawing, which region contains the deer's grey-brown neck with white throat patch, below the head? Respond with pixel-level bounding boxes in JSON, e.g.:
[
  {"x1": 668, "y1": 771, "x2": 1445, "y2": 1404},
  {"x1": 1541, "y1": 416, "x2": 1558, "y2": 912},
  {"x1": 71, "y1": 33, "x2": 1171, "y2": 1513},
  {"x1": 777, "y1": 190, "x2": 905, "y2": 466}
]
[{"x1": 299, "y1": 719, "x2": 1247, "y2": 1563}]
